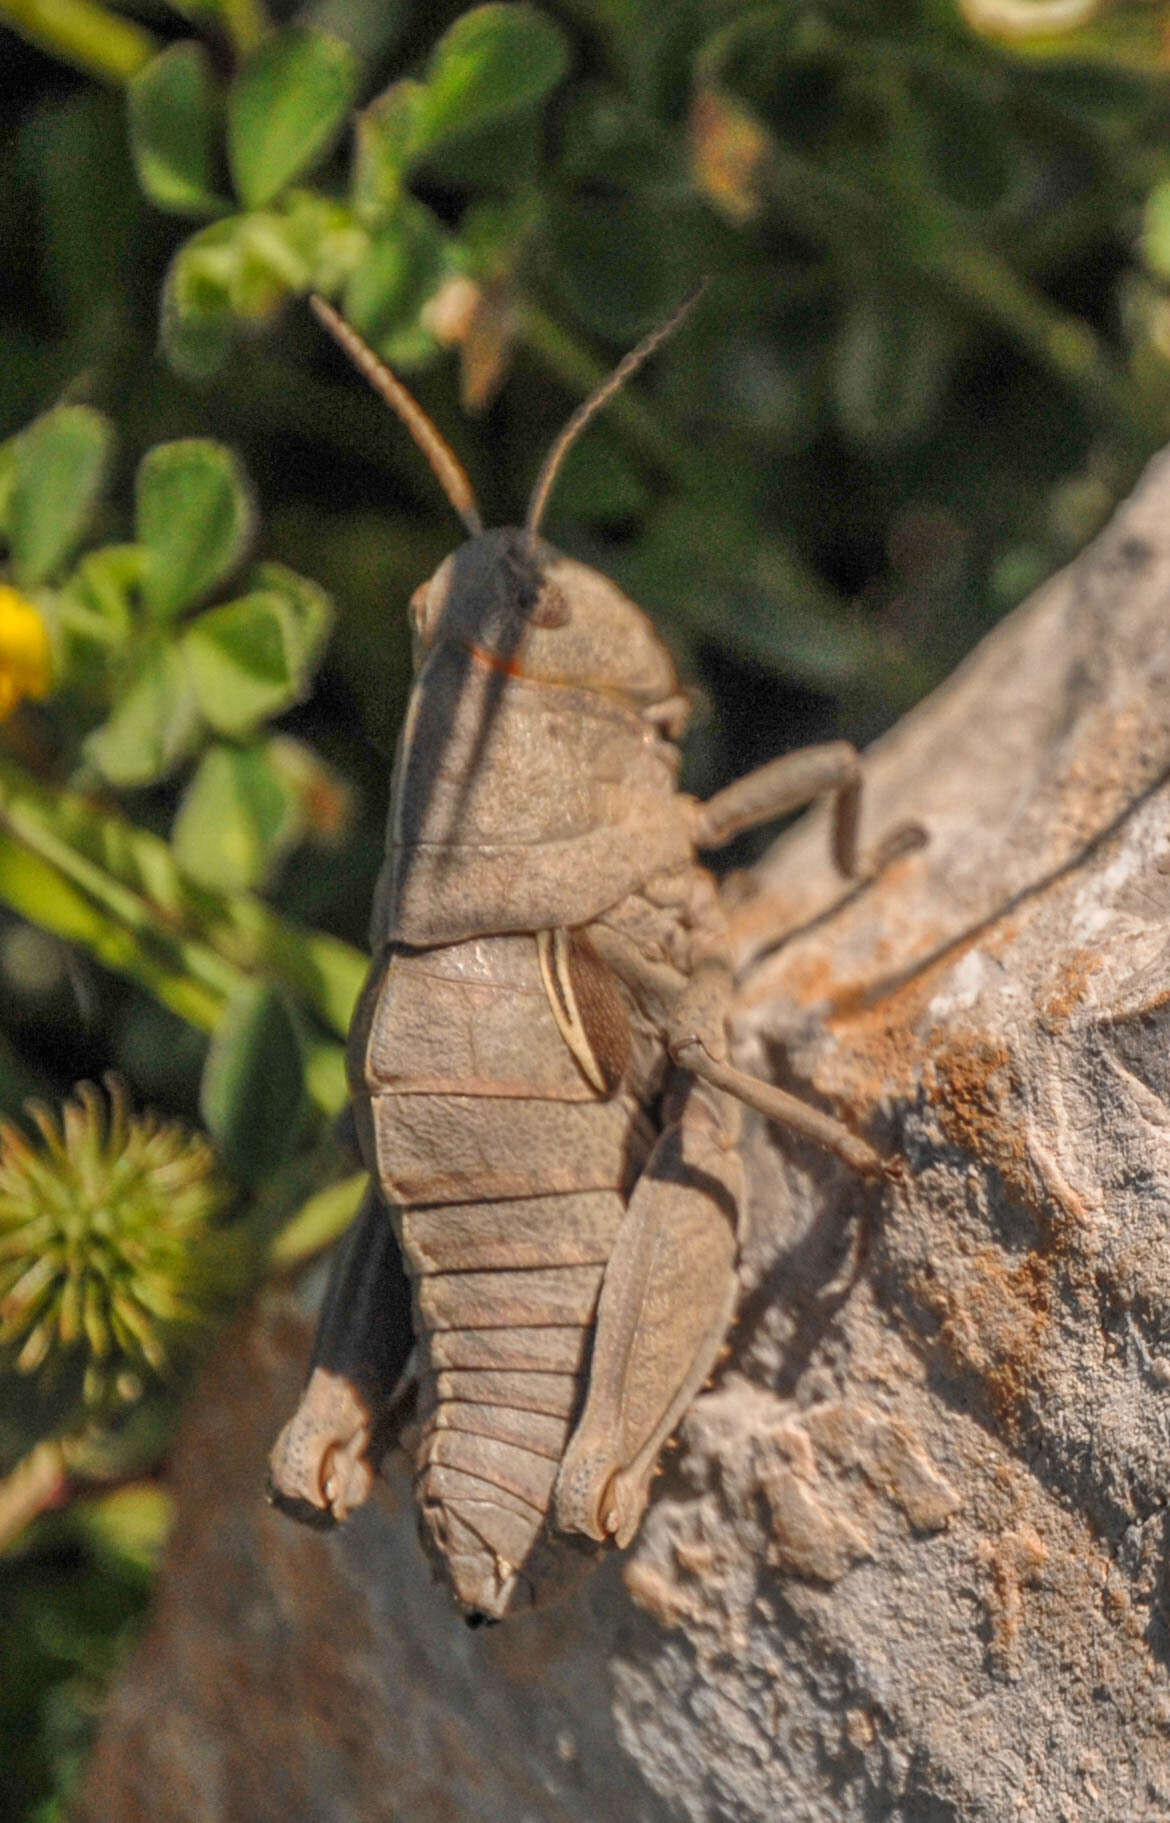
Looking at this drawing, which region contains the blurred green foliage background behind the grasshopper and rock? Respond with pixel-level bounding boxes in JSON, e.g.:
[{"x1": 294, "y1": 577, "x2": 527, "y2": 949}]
[{"x1": 0, "y1": 0, "x2": 1170, "y2": 1819}]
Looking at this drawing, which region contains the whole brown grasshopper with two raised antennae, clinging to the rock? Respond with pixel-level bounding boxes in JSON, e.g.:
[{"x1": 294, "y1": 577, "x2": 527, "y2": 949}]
[{"x1": 272, "y1": 288, "x2": 919, "y2": 1619}]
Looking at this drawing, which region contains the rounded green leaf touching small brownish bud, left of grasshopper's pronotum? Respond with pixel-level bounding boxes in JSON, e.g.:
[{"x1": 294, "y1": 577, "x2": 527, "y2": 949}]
[{"x1": 173, "y1": 746, "x2": 303, "y2": 893}]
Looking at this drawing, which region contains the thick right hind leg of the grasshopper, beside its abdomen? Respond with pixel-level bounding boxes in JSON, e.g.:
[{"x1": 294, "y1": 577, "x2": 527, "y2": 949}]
[{"x1": 554, "y1": 1083, "x2": 744, "y2": 1546}]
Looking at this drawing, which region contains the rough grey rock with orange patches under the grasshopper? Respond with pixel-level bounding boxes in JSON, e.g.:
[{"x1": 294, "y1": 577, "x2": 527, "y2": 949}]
[{"x1": 82, "y1": 458, "x2": 1170, "y2": 1823}]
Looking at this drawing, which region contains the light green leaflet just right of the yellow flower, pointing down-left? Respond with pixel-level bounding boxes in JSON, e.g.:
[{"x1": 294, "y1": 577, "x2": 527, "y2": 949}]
[{"x1": 86, "y1": 636, "x2": 199, "y2": 789}]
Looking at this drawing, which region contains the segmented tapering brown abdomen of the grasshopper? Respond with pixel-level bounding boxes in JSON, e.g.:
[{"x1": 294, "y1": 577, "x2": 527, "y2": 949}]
[{"x1": 350, "y1": 935, "x2": 654, "y2": 1613}]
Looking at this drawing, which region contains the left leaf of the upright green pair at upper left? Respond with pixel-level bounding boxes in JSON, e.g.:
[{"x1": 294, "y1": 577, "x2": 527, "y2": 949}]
[{"x1": 128, "y1": 42, "x2": 228, "y2": 215}]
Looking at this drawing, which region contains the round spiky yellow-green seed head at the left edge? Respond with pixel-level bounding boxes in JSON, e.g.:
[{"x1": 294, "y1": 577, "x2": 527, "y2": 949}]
[{"x1": 0, "y1": 1077, "x2": 250, "y2": 1435}]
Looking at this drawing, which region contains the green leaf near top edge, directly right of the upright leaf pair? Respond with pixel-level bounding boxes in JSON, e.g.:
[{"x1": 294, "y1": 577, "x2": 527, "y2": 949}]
[{"x1": 414, "y1": 5, "x2": 569, "y2": 153}]
